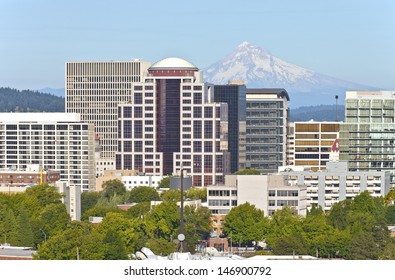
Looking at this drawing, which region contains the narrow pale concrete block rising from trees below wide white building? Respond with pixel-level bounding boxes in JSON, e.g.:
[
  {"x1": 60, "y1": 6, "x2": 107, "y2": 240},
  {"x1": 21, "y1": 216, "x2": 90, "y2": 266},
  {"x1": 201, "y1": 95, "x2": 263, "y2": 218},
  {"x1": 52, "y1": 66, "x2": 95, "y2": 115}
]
[{"x1": 56, "y1": 181, "x2": 81, "y2": 221}]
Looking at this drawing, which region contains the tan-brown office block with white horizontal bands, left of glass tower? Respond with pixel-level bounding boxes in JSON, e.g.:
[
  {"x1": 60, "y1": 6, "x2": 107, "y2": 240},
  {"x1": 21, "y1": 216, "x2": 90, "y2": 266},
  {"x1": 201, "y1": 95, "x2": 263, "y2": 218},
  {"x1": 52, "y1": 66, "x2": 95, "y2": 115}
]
[{"x1": 292, "y1": 121, "x2": 340, "y2": 171}]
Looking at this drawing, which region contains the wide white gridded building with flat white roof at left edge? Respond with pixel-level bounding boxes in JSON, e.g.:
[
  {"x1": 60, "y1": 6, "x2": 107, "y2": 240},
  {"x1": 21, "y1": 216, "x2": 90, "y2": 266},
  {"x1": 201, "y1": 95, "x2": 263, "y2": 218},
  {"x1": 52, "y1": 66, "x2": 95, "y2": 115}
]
[{"x1": 0, "y1": 113, "x2": 95, "y2": 191}]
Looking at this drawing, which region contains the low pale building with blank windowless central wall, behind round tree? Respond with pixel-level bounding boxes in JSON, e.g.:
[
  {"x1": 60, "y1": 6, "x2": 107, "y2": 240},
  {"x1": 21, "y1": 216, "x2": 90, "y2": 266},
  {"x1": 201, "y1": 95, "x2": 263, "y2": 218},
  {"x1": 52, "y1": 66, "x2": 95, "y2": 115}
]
[{"x1": 207, "y1": 175, "x2": 306, "y2": 216}]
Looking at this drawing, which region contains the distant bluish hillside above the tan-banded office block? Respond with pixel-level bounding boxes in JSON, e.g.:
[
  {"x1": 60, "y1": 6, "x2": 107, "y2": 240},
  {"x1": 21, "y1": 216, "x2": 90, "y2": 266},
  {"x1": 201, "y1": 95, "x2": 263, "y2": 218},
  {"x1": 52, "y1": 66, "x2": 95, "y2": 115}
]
[{"x1": 290, "y1": 105, "x2": 344, "y2": 122}]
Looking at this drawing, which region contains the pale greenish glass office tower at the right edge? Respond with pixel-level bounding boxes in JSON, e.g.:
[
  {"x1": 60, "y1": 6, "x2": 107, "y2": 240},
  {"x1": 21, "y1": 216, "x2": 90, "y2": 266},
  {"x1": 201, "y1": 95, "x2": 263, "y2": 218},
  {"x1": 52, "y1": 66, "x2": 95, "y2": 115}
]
[{"x1": 340, "y1": 91, "x2": 395, "y2": 189}]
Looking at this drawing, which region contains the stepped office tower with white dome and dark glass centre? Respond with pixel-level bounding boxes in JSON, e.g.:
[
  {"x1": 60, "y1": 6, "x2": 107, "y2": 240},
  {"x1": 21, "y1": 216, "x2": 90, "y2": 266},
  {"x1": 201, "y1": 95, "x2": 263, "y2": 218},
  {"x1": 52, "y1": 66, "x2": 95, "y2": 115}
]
[{"x1": 116, "y1": 58, "x2": 229, "y2": 186}]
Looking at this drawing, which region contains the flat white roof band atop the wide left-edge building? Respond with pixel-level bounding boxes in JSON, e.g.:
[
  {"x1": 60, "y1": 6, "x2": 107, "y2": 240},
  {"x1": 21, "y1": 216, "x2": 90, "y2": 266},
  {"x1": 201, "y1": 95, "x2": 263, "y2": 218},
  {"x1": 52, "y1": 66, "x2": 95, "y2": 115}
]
[{"x1": 0, "y1": 113, "x2": 81, "y2": 123}]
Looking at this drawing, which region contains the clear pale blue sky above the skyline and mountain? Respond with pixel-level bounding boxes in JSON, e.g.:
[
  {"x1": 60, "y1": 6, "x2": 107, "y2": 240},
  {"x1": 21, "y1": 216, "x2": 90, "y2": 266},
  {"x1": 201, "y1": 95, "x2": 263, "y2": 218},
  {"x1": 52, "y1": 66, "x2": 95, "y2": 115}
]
[{"x1": 0, "y1": 0, "x2": 395, "y2": 89}]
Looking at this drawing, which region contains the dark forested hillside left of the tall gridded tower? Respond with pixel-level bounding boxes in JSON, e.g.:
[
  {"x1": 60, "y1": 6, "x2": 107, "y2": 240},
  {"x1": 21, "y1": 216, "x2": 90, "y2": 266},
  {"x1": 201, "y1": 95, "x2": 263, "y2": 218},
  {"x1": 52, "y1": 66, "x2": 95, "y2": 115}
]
[{"x1": 0, "y1": 87, "x2": 64, "y2": 112}]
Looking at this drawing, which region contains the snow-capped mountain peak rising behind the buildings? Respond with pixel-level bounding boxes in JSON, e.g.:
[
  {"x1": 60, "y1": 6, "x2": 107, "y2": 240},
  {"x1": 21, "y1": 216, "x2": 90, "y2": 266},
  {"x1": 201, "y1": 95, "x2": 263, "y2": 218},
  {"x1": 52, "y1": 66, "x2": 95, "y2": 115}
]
[{"x1": 203, "y1": 42, "x2": 377, "y2": 108}]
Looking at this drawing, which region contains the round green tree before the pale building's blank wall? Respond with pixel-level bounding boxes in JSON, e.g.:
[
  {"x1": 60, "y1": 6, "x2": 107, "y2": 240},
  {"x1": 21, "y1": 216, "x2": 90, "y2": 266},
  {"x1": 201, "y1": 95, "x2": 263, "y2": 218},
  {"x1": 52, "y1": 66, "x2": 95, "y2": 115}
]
[{"x1": 223, "y1": 202, "x2": 268, "y2": 245}]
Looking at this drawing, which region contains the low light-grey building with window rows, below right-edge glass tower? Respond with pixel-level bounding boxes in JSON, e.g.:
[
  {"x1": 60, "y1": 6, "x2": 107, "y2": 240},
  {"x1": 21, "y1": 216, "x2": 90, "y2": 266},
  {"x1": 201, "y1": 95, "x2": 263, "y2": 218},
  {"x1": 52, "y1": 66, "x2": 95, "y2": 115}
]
[{"x1": 279, "y1": 162, "x2": 390, "y2": 211}]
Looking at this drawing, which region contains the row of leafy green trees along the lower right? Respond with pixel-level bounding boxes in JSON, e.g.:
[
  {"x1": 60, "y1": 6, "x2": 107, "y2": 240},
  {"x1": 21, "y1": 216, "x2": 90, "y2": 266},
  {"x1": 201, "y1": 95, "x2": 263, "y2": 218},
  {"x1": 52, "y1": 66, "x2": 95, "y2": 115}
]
[{"x1": 224, "y1": 192, "x2": 395, "y2": 260}]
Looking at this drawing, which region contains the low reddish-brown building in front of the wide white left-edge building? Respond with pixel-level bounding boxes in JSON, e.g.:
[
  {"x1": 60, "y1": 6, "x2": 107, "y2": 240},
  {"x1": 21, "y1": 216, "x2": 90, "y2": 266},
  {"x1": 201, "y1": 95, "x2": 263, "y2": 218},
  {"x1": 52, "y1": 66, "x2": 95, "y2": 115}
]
[{"x1": 0, "y1": 164, "x2": 60, "y2": 194}]
